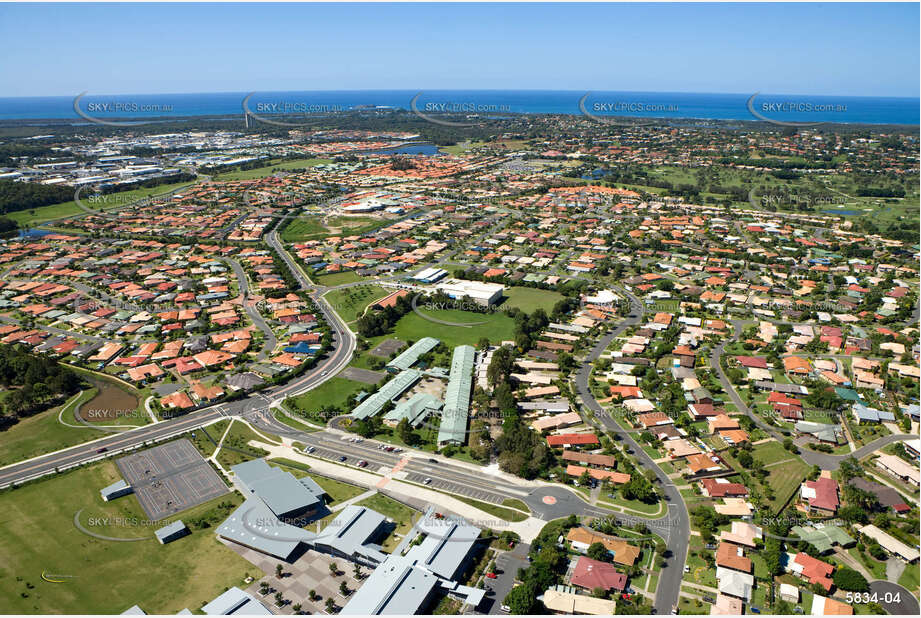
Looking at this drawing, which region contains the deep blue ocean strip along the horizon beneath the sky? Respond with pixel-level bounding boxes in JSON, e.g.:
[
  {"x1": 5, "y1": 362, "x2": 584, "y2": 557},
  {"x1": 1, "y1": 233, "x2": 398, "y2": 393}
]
[{"x1": 0, "y1": 90, "x2": 919, "y2": 125}]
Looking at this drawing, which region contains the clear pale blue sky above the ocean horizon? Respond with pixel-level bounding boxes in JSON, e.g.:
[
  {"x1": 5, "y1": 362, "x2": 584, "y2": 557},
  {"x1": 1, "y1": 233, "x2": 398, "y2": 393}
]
[{"x1": 0, "y1": 3, "x2": 919, "y2": 97}]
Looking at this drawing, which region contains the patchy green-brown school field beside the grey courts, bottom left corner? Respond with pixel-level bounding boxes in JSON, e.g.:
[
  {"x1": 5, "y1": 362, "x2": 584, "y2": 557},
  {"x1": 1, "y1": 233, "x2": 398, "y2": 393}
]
[{"x1": 0, "y1": 461, "x2": 262, "y2": 614}]
